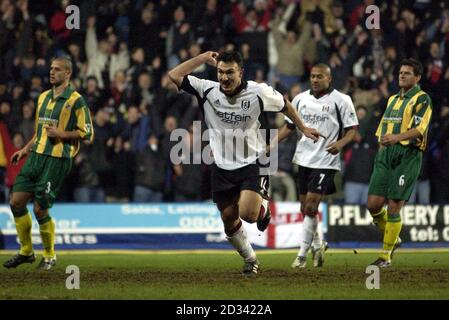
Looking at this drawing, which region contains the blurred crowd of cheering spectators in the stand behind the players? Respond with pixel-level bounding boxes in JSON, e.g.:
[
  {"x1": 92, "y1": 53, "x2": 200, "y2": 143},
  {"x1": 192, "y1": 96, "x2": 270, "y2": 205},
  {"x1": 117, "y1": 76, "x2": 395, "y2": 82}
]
[{"x1": 0, "y1": 0, "x2": 449, "y2": 204}]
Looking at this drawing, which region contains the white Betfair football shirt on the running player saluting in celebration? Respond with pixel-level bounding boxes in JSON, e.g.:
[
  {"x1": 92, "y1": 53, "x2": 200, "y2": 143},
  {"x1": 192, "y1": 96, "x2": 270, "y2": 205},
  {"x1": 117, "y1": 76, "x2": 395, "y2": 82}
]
[{"x1": 181, "y1": 75, "x2": 286, "y2": 170}]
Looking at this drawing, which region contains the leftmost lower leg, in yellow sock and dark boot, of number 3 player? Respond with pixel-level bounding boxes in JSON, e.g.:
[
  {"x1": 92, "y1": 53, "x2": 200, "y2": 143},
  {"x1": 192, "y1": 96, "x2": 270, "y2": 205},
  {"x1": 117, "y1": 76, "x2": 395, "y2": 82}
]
[{"x1": 3, "y1": 192, "x2": 36, "y2": 269}]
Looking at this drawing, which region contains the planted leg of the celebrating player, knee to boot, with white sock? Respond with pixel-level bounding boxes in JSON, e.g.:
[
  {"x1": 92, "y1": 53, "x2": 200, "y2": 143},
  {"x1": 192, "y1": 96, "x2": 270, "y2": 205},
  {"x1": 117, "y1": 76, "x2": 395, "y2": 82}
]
[{"x1": 217, "y1": 196, "x2": 259, "y2": 276}]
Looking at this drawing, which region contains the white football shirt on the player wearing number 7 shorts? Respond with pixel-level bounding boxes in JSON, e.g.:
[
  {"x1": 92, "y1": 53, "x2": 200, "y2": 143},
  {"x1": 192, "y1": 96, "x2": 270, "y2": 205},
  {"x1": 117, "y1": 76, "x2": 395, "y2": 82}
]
[{"x1": 285, "y1": 89, "x2": 359, "y2": 170}]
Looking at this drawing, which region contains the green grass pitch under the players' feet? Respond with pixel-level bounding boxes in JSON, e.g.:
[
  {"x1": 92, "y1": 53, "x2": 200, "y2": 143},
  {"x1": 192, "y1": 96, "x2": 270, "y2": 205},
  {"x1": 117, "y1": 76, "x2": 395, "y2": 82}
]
[{"x1": 0, "y1": 249, "x2": 449, "y2": 300}]
